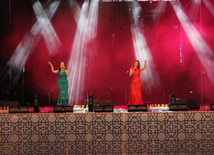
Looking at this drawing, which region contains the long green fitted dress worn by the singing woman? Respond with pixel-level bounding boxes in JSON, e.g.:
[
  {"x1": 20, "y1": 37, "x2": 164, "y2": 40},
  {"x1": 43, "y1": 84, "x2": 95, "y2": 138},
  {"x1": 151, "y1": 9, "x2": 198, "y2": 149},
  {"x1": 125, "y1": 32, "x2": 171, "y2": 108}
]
[{"x1": 57, "y1": 70, "x2": 68, "y2": 106}]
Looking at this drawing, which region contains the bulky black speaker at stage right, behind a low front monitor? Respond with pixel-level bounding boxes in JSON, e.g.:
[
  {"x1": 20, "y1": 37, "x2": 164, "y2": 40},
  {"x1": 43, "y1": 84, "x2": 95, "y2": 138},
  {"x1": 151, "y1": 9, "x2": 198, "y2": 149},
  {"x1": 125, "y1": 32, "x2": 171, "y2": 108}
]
[{"x1": 176, "y1": 99, "x2": 200, "y2": 110}]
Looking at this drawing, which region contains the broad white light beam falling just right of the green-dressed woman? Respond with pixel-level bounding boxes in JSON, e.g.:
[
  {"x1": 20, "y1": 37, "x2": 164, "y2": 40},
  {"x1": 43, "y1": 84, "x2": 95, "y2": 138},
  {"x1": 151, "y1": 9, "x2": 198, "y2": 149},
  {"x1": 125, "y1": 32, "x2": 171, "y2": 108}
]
[{"x1": 68, "y1": 0, "x2": 99, "y2": 105}]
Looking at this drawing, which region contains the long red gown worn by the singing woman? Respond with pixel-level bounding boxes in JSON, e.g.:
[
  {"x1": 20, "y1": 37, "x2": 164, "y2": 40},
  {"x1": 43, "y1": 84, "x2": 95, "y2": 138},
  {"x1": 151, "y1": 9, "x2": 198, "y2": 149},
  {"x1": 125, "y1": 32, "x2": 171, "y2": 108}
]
[{"x1": 128, "y1": 68, "x2": 143, "y2": 105}]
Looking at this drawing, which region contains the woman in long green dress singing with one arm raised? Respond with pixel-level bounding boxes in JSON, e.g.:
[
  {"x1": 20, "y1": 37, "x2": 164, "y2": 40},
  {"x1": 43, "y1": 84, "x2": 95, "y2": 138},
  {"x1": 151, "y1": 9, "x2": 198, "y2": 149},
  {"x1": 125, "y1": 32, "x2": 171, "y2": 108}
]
[{"x1": 48, "y1": 62, "x2": 69, "y2": 106}]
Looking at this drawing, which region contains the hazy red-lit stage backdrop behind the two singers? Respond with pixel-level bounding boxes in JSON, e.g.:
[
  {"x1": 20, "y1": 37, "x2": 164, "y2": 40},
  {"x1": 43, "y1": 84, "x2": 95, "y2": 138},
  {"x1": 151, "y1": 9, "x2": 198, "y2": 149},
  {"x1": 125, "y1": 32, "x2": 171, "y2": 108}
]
[{"x1": 0, "y1": 0, "x2": 214, "y2": 105}]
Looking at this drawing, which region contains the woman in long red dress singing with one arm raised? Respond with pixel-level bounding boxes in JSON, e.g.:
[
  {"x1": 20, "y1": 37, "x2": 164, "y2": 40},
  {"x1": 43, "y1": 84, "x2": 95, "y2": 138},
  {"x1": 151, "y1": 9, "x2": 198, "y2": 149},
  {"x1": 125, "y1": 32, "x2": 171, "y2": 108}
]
[{"x1": 128, "y1": 59, "x2": 146, "y2": 105}]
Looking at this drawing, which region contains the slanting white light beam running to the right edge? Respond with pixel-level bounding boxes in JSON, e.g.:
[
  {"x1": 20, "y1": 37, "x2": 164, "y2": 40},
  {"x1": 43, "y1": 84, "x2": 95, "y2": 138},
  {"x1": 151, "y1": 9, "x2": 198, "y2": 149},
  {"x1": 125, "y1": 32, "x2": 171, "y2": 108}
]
[{"x1": 171, "y1": 2, "x2": 214, "y2": 85}]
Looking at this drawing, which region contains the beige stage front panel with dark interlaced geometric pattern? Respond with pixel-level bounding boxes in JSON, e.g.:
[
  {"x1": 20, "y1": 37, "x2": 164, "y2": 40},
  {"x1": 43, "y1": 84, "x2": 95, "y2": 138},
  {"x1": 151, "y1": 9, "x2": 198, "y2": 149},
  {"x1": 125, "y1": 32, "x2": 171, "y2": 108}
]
[{"x1": 0, "y1": 111, "x2": 214, "y2": 155}]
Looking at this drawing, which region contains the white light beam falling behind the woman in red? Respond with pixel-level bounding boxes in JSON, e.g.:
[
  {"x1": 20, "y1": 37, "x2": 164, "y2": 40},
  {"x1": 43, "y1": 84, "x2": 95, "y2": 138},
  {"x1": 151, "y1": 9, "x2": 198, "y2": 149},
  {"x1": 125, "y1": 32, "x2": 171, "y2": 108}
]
[{"x1": 131, "y1": 1, "x2": 159, "y2": 91}]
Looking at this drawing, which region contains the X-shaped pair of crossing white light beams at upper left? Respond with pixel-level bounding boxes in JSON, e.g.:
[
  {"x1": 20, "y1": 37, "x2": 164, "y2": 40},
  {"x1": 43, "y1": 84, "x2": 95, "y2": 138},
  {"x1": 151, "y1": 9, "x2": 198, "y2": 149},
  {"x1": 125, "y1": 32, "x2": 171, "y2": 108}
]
[{"x1": 7, "y1": 1, "x2": 61, "y2": 86}]
